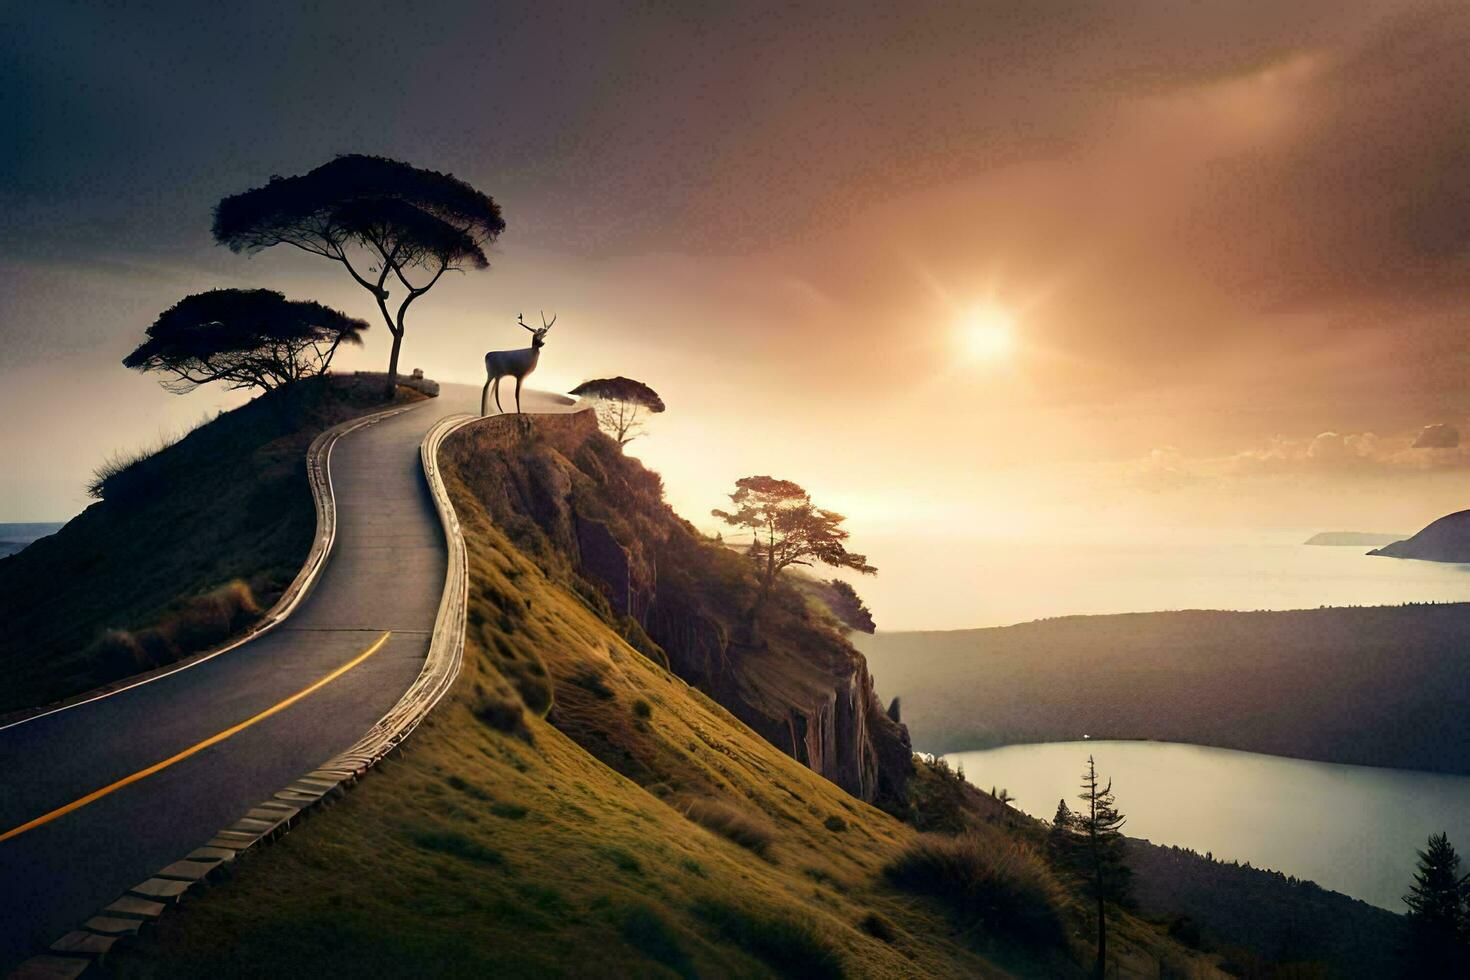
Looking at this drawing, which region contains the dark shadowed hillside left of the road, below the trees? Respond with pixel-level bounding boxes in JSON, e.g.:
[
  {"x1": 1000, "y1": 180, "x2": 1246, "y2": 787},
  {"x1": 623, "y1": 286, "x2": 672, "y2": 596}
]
[{"x1": 0, "y1": 376, "x2": 420, "y2": 714}]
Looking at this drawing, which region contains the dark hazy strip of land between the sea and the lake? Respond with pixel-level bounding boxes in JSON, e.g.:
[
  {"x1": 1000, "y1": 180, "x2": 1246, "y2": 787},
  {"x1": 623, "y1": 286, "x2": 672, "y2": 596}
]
[{"x1": 854, "y1": 604, "x2": 1470, "y2": 773}]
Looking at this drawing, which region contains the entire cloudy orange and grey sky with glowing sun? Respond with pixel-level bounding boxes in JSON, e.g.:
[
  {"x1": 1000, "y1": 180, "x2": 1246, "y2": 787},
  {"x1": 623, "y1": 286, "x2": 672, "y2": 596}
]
[{"x1": 0, "y1": 0, "x2": 1470, "y2": 626}]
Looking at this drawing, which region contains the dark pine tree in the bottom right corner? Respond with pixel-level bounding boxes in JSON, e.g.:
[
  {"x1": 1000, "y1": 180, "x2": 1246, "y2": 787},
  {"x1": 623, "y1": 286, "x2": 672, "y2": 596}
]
[{"x1": 1404, "y1": 833, "x2": 1470, "y2": 977}]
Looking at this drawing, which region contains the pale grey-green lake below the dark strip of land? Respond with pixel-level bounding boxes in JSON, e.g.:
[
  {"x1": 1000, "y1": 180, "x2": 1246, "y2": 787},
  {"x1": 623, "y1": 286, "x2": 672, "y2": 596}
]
[{"x1": 945, "y1": 741, "x2": 1470, "y2": 912}]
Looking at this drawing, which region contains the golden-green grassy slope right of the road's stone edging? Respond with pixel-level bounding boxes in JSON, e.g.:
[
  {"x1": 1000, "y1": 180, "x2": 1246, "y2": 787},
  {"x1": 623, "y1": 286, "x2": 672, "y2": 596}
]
[{"x1": 113, "y1": 423, "x2": 1214, "y2": 977}]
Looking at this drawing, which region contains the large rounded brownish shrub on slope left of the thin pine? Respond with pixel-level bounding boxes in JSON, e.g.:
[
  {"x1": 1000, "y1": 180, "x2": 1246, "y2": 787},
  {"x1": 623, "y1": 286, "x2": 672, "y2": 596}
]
[{"x1": 883, "y1": 835, "x2": 1064, "y2": 945}]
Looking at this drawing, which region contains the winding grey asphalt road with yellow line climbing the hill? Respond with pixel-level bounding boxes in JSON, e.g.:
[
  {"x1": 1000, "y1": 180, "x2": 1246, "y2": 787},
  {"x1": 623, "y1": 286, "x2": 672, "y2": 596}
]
[{"x1": 0, "y1": 385, "x2": 575, "y2": 971}]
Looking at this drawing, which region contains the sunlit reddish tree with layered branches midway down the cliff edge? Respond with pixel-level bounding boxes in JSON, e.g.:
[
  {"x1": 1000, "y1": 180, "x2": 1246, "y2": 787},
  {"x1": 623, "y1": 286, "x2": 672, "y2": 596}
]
[{"x1": 710, "y1": 476, "x2": 878, "y2": 620}]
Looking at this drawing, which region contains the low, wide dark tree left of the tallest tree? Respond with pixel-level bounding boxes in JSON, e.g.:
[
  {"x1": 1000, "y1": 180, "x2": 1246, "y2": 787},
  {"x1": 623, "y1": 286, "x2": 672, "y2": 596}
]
[{"x1": 122, "y1": 289, "x2": 368, "y2": 394}]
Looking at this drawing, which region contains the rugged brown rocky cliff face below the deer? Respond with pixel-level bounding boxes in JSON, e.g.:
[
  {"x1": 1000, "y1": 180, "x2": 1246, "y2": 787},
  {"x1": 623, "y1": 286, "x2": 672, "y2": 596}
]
[{"x1": 445, "y1": 411, "x2": 911, "y2": 802}]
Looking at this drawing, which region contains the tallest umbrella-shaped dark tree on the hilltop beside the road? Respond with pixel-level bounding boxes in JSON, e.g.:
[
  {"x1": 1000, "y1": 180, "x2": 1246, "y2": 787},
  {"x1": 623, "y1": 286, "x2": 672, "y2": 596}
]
[{"x1": 213, "y1": 153, "x2": 506, "y2": 398}]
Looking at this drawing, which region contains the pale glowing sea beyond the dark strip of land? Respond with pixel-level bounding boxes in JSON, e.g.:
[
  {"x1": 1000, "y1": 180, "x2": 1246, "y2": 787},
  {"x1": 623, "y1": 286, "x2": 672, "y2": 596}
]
[{"x1": 853, "y1": 527, "x2": 1470, "y2": 630}]
